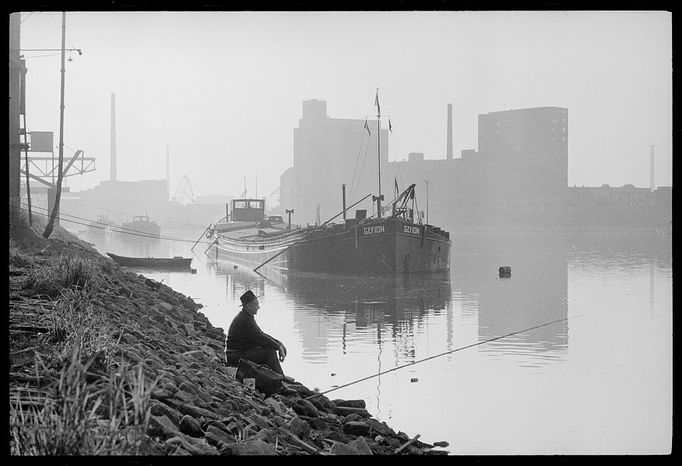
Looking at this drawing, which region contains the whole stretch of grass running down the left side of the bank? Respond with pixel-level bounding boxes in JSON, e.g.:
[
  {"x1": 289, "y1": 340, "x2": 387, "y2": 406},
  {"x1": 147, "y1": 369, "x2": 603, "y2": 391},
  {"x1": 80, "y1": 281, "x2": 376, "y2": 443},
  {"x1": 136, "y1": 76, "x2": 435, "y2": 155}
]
[{"x1": 9, "y1": 219, "x2": 156, "y2": 455}]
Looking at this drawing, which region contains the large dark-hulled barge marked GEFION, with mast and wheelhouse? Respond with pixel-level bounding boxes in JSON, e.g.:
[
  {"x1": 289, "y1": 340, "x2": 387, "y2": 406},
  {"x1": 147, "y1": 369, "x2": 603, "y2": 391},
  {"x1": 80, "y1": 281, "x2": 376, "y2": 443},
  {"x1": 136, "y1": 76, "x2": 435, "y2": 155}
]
[{"x1": 206, "y1": 94, "x2": 451, "y2": 275}]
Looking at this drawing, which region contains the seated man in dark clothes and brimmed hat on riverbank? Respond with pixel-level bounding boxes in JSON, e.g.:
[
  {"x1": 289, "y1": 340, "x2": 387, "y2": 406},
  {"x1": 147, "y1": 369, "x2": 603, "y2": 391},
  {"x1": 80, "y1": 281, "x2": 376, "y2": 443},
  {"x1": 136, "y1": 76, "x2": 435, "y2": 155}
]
[{"x1": 225, "y1": 290, "x2": 287, "y2": 375}]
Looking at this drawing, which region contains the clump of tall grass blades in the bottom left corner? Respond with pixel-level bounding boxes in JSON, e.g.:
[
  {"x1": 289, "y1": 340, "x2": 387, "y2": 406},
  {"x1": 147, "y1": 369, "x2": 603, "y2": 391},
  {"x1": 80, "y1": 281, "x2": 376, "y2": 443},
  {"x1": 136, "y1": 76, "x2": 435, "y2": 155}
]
[{"x1": 10, "y1": 347, "x2": 154, "y2": 455}]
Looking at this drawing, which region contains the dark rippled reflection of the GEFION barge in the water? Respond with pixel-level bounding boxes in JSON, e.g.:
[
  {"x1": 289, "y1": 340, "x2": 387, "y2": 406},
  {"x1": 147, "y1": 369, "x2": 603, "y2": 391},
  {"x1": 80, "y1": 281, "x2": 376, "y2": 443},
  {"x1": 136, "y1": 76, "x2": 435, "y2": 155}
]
[{"x1": 208, "y1": 262, "x2": 453, "y2": 361}]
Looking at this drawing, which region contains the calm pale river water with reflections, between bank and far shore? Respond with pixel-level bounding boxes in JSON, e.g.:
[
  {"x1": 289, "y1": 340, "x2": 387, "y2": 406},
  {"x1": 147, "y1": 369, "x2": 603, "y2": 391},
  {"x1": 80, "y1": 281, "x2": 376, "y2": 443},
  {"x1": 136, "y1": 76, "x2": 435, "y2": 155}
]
[{"x1": 75, "y1": 226, "x2": 672, "y2": 455}]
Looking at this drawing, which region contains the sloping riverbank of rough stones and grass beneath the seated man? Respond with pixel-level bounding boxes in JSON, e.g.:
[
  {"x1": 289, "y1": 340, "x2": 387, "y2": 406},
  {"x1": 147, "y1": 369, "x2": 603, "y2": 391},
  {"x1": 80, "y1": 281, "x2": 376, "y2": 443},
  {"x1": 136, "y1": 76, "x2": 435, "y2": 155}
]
[{"x1": 9, "y1": 222, "x2": 447, "y2": 455}]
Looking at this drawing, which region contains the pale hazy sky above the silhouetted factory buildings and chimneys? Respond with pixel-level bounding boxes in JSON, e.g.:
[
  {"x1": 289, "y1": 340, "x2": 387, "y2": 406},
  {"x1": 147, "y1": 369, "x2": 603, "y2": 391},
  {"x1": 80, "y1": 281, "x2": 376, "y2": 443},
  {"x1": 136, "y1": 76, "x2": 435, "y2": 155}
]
[{"x1": 21, "y1": 11, "x2": 672, "y2": 197}]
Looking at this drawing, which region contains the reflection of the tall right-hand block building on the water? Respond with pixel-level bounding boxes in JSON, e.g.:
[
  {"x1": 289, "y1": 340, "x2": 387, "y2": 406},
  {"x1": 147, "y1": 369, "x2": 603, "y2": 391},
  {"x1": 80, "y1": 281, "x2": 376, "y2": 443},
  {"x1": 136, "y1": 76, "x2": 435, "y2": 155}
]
[{"x1": 453, "y1": 232, "x2": 570, "y2": 366}]
